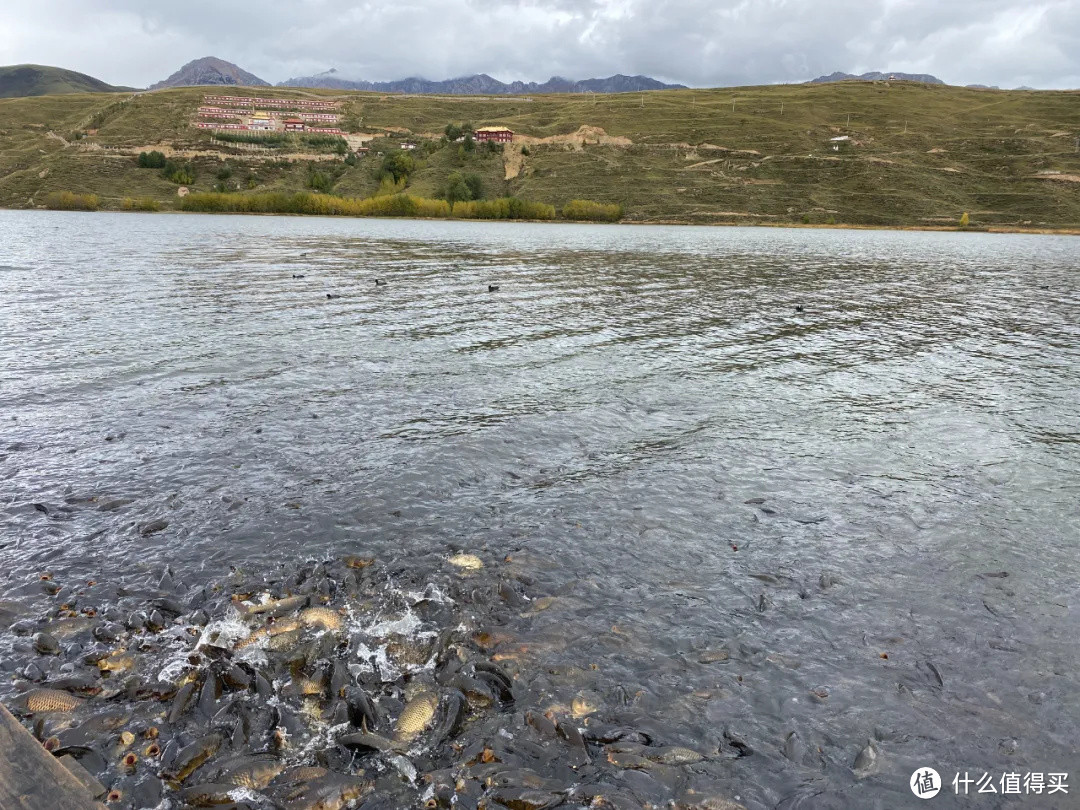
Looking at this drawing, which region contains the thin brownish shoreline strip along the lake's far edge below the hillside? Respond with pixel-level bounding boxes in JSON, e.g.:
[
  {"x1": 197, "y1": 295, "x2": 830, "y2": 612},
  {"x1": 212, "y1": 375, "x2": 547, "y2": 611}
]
[{"x1": 0, "y1": 206, "x2": 1080, "y2": 237}]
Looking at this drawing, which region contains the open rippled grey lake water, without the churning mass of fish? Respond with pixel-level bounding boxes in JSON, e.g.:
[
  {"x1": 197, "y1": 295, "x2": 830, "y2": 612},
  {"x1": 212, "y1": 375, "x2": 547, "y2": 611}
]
[{"x1": 0, "y1": 212, "x2": 1080, "y2": 810}]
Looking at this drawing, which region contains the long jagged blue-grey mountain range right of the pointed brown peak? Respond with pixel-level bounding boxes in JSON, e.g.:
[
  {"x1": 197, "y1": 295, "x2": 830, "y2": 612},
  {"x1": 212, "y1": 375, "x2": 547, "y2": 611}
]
[{"x1": 278, "y1": 68, "x2": 686, "y2": 96}]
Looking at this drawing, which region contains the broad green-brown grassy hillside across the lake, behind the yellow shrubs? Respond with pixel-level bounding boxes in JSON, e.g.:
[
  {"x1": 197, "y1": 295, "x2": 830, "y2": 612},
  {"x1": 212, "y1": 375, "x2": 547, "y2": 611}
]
[{"x1": 0, "y1": 82, "x2": 1080, "y2": 228}]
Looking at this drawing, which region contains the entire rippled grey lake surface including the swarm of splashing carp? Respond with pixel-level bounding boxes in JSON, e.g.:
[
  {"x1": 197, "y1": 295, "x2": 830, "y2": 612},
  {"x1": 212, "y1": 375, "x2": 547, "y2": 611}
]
[{"x1": 0, "y1": 212, "x2": 1080, "y2": 810}]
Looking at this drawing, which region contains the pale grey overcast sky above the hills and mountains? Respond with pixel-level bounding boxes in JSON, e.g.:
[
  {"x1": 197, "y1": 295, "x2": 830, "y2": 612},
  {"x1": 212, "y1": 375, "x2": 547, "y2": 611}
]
[{"x1": 0, "y1": 0, "x2": 1080, "y2": 87}]
